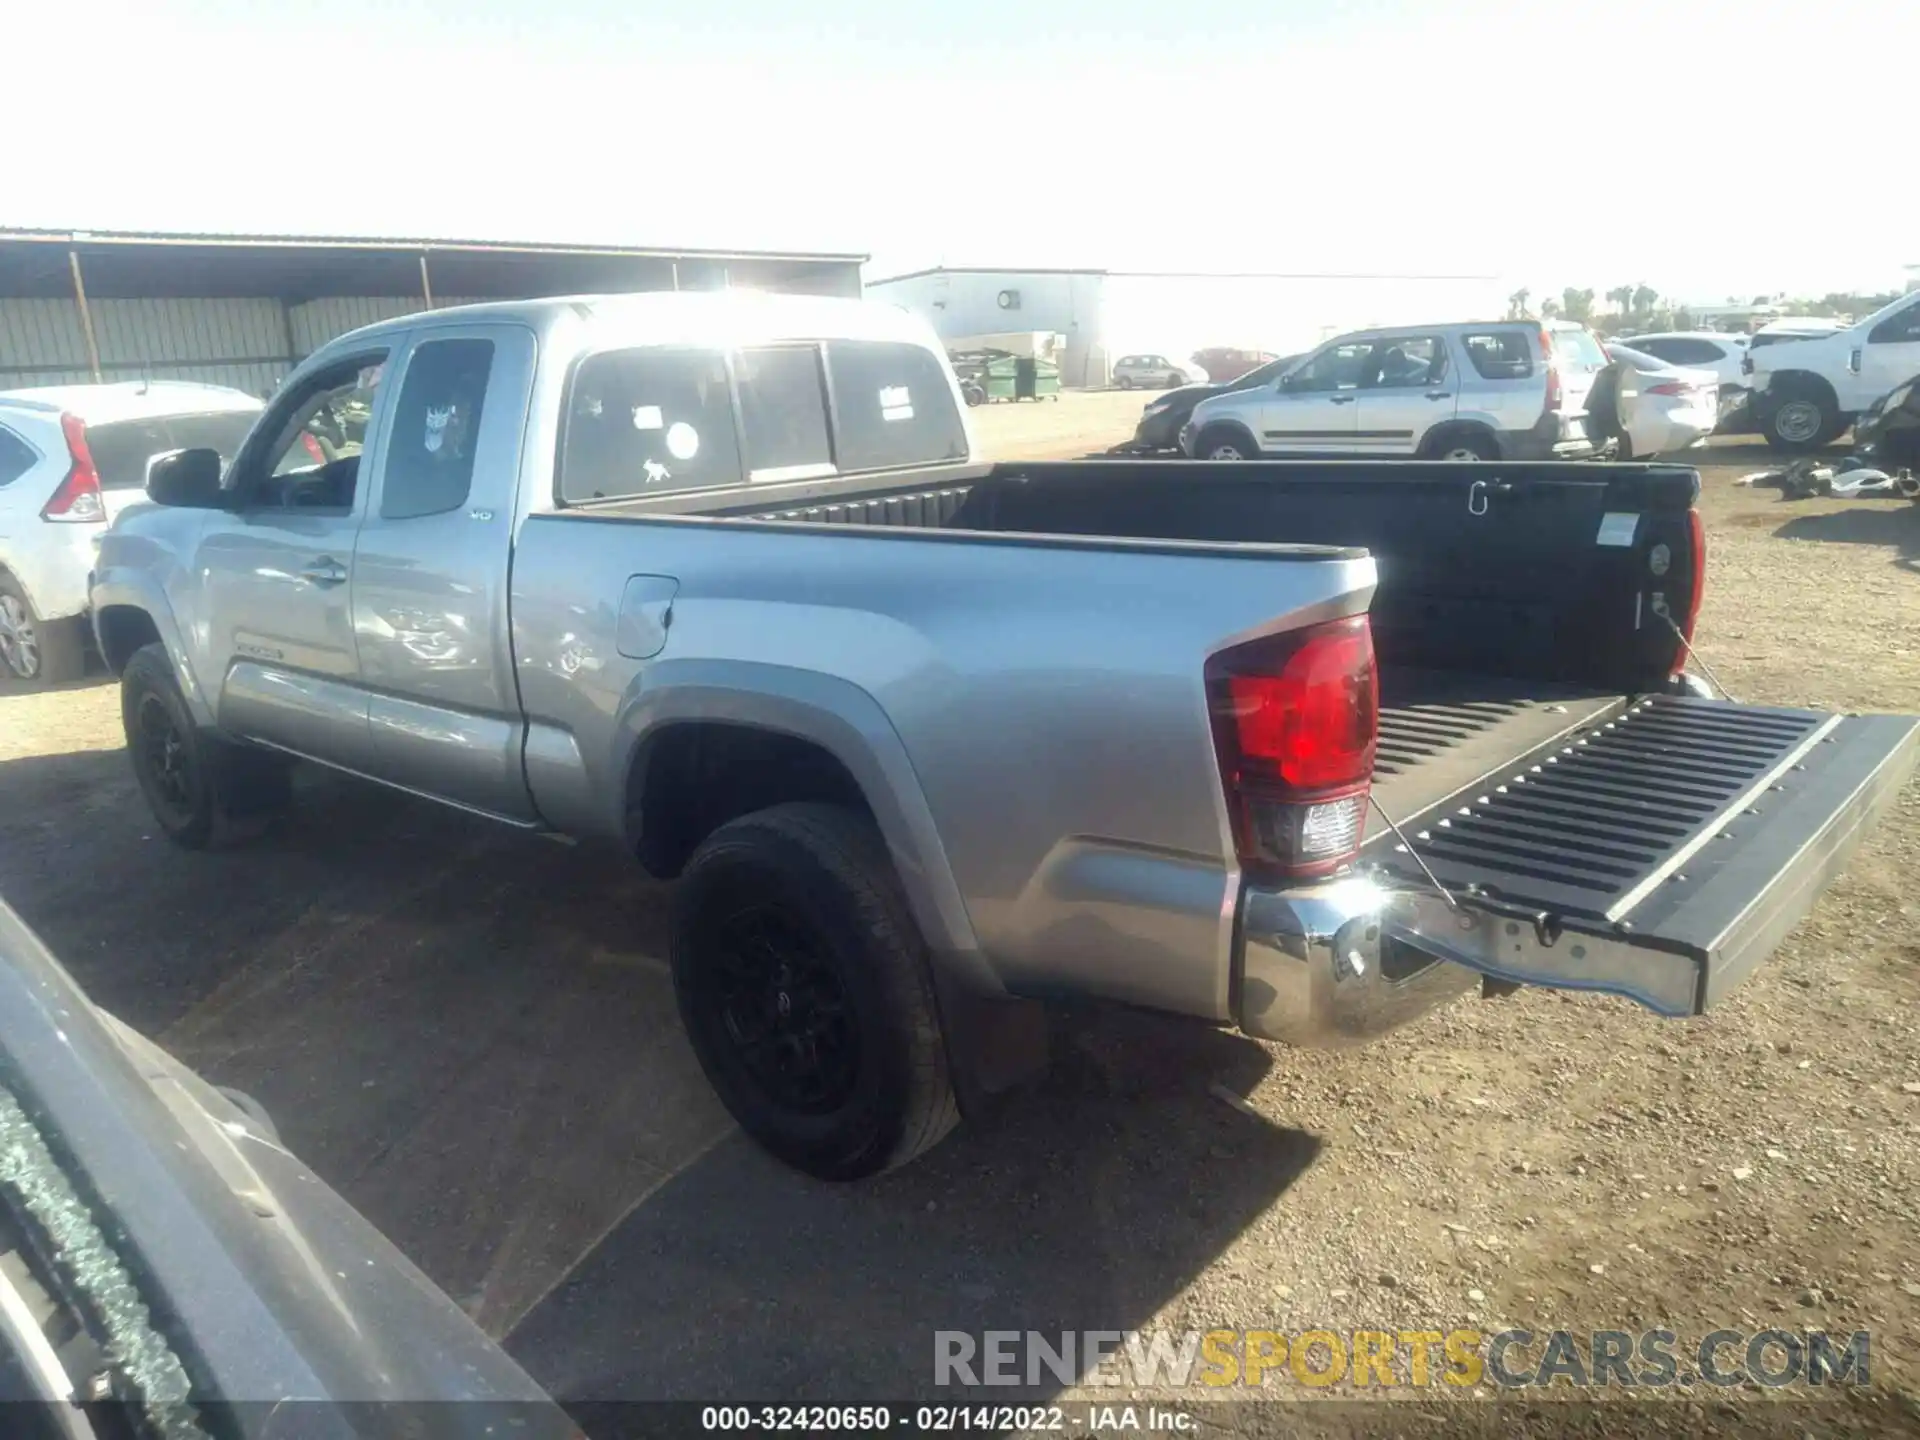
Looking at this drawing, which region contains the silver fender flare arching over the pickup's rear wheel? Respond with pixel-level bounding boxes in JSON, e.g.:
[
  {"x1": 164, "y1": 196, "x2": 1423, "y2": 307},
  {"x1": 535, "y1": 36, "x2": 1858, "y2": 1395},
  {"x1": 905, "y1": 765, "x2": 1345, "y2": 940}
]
[{"x1": 609, "y1": 659, "x2": 1004, "y2": 995}]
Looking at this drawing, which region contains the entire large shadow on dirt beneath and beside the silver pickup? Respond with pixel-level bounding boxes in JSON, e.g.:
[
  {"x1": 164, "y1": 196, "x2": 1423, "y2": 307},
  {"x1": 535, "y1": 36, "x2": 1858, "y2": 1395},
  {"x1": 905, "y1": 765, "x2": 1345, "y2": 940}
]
[{"x1": 0, "y1": 749, "x2": 1319, "y2": 1400}]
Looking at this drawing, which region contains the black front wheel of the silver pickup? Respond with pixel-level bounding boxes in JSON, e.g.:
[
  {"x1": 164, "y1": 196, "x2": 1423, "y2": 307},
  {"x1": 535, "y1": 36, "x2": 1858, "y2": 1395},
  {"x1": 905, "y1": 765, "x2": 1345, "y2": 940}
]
[{"x1": 121, "y1": 645, "x2": 292, "y2": 851}]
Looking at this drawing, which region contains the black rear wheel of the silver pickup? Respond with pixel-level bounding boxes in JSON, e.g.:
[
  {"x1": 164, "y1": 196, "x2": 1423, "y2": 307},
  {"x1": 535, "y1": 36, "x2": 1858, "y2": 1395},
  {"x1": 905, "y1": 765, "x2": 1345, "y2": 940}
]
[{"x1": 672, "y1": 804, "x2": 960, "y2": 1181}]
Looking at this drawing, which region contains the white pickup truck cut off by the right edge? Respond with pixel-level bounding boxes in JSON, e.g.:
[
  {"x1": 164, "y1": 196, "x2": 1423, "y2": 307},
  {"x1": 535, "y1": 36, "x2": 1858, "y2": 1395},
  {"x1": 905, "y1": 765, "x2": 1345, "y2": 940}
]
[{"x1": 1741, "y1": 294, "x2": 1920, "y2": 451}]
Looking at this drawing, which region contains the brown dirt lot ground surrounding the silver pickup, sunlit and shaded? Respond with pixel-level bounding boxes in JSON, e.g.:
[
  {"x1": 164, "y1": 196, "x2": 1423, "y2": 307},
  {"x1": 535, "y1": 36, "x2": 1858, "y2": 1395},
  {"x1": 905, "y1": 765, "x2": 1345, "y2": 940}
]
[{"x1": 0, "y1": 394, "x2": 1920, "y2": 1434}]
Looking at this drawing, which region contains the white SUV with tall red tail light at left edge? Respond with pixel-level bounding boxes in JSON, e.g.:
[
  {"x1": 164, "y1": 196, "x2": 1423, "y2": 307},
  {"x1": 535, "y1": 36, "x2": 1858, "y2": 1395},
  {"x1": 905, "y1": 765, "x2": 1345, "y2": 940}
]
[{"x1": 0, "y1": 380, "x2": 261, "y2": 685}]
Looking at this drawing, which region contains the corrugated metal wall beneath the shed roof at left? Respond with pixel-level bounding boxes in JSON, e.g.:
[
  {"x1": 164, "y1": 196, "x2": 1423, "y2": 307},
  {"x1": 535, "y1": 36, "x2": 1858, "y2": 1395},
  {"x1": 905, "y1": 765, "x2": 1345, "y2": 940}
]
[{"x1": 0, "y1": 296, "x2": 472, "y2": 396}]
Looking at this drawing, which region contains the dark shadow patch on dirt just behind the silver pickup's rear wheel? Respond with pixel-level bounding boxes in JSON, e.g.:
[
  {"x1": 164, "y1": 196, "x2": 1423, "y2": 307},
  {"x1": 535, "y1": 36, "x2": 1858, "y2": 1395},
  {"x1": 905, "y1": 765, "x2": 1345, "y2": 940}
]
[{"x1": 509, "y1": 1012, "x2": 1321, "y2": 1405}]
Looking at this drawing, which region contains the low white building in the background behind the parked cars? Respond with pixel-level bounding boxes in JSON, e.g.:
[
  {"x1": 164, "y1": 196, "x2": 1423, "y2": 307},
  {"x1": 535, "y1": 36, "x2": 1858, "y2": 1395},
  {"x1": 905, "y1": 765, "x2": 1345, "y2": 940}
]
[{"x1": 866, "y1": 267, "x2": 1507, "y2": 386}]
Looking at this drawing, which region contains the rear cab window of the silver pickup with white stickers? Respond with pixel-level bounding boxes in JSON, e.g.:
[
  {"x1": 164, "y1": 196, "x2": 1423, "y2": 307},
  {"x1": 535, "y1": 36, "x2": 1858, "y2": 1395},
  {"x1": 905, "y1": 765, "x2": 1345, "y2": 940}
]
[{"x1": 557, "y1": 340, "x2": 968, "y2": 505}]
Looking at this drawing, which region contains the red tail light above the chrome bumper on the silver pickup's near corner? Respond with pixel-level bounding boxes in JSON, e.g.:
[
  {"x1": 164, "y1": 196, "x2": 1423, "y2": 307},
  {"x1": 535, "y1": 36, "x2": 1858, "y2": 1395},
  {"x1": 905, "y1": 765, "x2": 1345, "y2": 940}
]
[{"x1": 1208, "y1": 614, "x2": 1380, "y2": 877}]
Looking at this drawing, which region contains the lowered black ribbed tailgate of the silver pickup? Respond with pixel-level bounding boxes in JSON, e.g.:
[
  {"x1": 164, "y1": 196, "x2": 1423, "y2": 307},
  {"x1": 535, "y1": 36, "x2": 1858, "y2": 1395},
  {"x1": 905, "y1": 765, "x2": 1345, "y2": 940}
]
[{"x1": 1367, "y1": 695, "x2": 1920, "y2": 1016}]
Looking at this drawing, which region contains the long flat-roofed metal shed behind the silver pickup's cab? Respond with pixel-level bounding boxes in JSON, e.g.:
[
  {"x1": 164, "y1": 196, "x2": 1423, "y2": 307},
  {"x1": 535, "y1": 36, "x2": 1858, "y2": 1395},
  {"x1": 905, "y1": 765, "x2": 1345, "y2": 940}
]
[{"x1": 0, "y1": 230, "x2": 866, "y2": 394}]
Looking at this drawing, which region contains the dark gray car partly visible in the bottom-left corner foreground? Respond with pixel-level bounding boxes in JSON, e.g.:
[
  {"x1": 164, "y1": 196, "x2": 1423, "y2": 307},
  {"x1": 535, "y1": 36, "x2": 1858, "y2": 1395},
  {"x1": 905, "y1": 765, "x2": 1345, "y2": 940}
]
[{"x1": 0, "y1": 902, "x2": 578, "y2": 1440}]
